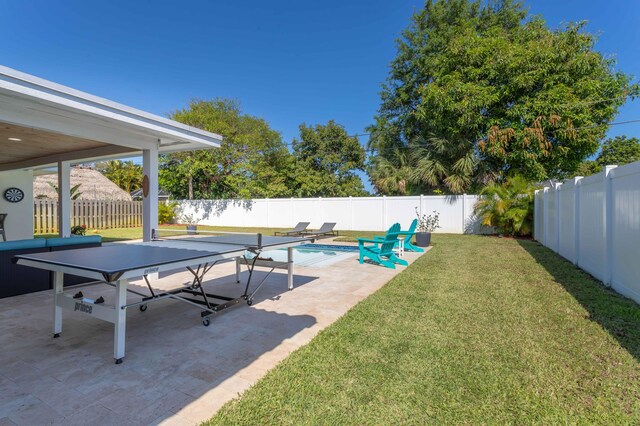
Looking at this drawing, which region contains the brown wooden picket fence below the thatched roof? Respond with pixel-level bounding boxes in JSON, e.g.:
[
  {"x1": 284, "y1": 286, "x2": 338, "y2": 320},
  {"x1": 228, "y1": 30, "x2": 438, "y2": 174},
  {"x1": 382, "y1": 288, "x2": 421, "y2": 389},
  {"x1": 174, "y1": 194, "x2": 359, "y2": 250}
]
[{"x1": 33, "y1": 200, "x2": 142, "y2": 234}]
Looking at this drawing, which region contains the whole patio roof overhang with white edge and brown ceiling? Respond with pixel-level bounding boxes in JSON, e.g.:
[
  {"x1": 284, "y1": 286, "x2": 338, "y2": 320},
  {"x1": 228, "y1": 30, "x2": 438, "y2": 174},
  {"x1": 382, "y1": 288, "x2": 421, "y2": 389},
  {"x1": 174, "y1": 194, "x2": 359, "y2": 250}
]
[{"x1": 0, "y1": 66, "x2": 222, "y2": 171}]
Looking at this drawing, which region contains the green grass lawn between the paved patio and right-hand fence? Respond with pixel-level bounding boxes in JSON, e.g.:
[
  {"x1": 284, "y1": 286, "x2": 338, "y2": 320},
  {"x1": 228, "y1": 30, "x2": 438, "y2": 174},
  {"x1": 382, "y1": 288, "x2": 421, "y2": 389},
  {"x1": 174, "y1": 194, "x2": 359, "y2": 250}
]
[{"x1": 205, "y1": 235, "x2": 640, "y2": 425}]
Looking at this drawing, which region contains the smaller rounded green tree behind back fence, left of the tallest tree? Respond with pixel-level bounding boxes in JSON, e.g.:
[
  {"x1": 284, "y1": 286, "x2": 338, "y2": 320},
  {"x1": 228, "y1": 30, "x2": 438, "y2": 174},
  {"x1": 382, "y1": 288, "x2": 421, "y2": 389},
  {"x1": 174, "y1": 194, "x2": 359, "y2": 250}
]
[{"x1": 293, "y1": 120, "x2": 366, "y2": 197}]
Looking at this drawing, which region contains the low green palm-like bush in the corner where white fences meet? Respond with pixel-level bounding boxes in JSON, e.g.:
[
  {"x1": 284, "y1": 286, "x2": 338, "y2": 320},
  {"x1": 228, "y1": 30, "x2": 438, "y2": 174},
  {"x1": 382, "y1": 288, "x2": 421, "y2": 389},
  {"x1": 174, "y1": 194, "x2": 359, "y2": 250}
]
[{"x1": 474, "y1": 176, "x2": 535, "y2": 236}]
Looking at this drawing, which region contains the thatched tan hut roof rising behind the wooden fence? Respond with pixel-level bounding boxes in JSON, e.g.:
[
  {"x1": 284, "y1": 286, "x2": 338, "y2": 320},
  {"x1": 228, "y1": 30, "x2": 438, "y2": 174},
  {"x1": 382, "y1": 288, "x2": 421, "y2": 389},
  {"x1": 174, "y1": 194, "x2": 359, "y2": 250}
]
[{"x1": 33, "y1": 167, "x2": 131, "y2": 201}]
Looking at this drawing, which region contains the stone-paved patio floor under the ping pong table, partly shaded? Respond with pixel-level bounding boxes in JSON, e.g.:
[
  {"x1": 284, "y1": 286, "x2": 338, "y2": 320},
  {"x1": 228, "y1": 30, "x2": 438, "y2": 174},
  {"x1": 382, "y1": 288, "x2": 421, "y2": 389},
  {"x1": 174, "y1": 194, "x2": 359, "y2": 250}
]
[{"x1": 0, "y1": 245, "x2": 430, "y2": 425}]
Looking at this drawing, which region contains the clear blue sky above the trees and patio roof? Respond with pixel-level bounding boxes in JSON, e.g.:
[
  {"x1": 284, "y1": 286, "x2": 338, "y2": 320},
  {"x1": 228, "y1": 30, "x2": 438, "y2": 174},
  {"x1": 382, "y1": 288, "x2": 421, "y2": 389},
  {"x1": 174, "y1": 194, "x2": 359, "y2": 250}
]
[{"x1": 0, "y1": 0, "x2": 640, "y2": 190}]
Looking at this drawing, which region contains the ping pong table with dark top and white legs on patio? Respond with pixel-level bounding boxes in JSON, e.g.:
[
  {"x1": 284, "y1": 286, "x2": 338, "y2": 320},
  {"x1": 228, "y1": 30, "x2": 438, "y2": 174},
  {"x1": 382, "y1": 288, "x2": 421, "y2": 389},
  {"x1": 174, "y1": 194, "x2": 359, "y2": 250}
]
[{"x1": 14, "y1": 230, "x2": 313, "y2": 364}]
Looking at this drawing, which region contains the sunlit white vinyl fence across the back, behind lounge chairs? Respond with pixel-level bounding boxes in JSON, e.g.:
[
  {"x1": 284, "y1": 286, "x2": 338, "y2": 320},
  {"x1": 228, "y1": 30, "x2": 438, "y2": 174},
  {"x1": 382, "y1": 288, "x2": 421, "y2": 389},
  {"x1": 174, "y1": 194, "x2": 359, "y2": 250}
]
[{"x1": 178, "y1": 195, "x2": 480, "y2": 234}]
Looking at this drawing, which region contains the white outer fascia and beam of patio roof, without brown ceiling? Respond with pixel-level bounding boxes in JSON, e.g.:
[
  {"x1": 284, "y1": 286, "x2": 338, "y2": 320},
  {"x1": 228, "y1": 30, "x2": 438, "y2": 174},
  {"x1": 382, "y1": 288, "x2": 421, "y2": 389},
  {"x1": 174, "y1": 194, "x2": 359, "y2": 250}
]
[{"x1": 0, "y1": 65, "x2": 222, "y2": 158}]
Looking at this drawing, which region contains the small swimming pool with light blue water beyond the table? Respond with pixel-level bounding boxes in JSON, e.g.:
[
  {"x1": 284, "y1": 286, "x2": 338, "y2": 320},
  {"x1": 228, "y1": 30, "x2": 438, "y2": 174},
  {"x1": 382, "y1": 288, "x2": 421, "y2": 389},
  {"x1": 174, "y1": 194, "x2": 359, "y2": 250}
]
[{"x1": 247, "y1": 244, "x2": 358, "y2": 268}]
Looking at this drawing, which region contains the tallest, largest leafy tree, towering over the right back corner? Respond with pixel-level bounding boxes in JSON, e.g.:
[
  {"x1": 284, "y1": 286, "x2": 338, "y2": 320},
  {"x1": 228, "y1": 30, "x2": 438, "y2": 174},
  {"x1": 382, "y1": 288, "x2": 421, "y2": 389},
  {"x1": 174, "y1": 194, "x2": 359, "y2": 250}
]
[{"x1": 369, "y1": 0, "x2": 637, "y2": 193}]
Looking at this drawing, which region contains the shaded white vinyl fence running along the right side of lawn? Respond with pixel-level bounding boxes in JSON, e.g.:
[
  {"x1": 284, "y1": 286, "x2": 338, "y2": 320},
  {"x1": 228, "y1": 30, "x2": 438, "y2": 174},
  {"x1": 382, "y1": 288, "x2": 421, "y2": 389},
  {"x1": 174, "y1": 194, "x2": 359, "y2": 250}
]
[{"x1": 534, "y1": 161, "x2": 640, "y2": 303}]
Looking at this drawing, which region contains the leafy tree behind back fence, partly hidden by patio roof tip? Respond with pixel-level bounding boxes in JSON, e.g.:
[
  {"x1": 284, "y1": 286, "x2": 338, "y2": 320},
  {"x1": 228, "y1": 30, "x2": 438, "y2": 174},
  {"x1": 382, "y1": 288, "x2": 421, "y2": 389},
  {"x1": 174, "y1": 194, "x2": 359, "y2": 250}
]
[{"x1": 160, "y1": 99, "x2": 294, "y2": 199}]
